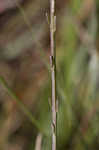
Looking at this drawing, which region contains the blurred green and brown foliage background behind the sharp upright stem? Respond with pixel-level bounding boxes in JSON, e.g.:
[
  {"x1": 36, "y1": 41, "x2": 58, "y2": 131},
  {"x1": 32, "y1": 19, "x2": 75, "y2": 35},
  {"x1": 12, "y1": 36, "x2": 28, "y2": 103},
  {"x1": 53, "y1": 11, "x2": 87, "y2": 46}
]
[{"x1": 0, "y1": 0, "x2": 99, "y2": 150}]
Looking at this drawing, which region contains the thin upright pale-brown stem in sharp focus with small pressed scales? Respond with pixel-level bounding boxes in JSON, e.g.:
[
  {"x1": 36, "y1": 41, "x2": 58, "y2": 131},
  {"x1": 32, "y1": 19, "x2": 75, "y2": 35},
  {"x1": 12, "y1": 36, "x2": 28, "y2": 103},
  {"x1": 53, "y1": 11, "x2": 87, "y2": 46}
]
[{"x1": 50, "y1": 0, "x2": 57, "y2": 150}]
